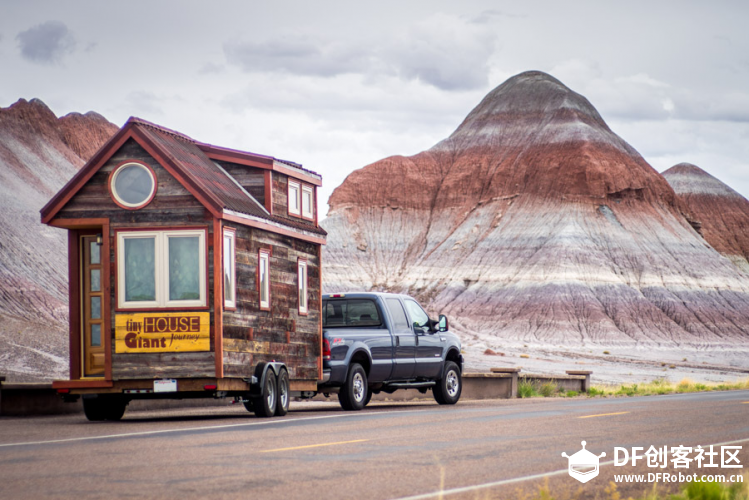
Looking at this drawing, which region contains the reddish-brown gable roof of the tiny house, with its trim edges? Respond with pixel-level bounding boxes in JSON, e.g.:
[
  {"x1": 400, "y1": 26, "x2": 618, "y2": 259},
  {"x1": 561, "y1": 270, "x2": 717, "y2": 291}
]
[{"x1": 41, "y1": 117, "x2": 326, "y2": 237}]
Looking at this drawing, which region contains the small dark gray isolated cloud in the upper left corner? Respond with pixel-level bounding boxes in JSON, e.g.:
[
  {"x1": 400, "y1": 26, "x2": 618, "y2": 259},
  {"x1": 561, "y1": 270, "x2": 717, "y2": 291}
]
[{"x1": 16, "y1": 21, "x2": 76, "y2": 64}]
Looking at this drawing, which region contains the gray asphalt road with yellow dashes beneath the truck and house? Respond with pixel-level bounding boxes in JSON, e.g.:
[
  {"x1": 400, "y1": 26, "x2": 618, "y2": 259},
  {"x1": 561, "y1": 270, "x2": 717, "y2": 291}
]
[{"x1": 0, "y1": 391, "x2": 749, "y2": 499}]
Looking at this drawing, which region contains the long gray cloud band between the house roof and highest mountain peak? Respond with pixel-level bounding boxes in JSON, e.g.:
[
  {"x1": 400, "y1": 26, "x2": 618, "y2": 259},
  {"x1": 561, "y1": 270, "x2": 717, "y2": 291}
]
[{"x1": 224, "y1": 13, "x2": 496, "y2": 90}]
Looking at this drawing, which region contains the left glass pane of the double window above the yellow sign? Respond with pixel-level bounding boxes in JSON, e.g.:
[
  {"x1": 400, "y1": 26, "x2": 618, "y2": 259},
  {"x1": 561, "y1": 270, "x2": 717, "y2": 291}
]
[{"x1": 125, "y1": 238, "x2": 156, "y2": 302}]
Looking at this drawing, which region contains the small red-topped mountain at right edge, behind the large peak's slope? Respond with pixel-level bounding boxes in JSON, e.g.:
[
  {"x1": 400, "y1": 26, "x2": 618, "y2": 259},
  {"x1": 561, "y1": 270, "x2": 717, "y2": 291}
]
[{"x1": 663, "y1": 163, "x2": 749, "y2": 273}]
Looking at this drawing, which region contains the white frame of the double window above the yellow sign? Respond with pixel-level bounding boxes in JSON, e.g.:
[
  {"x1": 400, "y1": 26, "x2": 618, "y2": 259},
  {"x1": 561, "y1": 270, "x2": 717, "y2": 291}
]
[{"x1": 117, "y1": 229, "x2": 206, "y2": 309}]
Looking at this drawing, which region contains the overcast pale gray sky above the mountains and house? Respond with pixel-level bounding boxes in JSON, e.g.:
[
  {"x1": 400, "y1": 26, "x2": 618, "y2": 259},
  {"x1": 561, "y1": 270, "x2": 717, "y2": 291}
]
[{"x1": 0, "y1": 0, "x2": 749, "y2": 212}]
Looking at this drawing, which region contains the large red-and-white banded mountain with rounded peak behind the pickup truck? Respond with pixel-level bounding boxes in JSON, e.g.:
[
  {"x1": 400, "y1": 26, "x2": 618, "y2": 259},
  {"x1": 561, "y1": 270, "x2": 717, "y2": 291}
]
[{"x1": 323, "y1": 72, "x2": 749, "y2": 347}]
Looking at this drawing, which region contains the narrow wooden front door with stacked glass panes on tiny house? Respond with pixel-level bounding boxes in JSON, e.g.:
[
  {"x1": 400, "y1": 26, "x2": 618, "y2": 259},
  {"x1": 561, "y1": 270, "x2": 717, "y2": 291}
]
[{"x1": 81, "y1": 235, "x2": 105, "y2": 377}]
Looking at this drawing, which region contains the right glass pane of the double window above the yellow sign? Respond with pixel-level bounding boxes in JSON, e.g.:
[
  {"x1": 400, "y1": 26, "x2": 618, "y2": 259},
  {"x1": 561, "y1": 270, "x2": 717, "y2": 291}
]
[{"x1": 169, "y1": 236, "x2": 200, "y2": 300}]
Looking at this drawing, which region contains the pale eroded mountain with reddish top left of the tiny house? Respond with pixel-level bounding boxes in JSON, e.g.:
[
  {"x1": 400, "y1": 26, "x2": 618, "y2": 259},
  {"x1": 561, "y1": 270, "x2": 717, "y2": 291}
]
[{"x1": 0, "y1": 99, "x2": 118, "y2": 380}]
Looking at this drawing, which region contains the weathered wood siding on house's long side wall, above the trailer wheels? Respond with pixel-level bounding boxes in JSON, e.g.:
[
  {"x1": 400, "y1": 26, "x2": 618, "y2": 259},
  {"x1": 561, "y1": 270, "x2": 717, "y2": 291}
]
[{"x1": 223, "y1": 225, "x2": 321, "y2": 380}]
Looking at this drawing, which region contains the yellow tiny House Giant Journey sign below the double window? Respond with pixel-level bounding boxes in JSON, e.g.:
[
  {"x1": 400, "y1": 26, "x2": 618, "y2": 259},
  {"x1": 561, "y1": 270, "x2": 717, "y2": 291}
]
[{"x1": 114, "y1": 312, "x2": 211, "y2": 353}]
